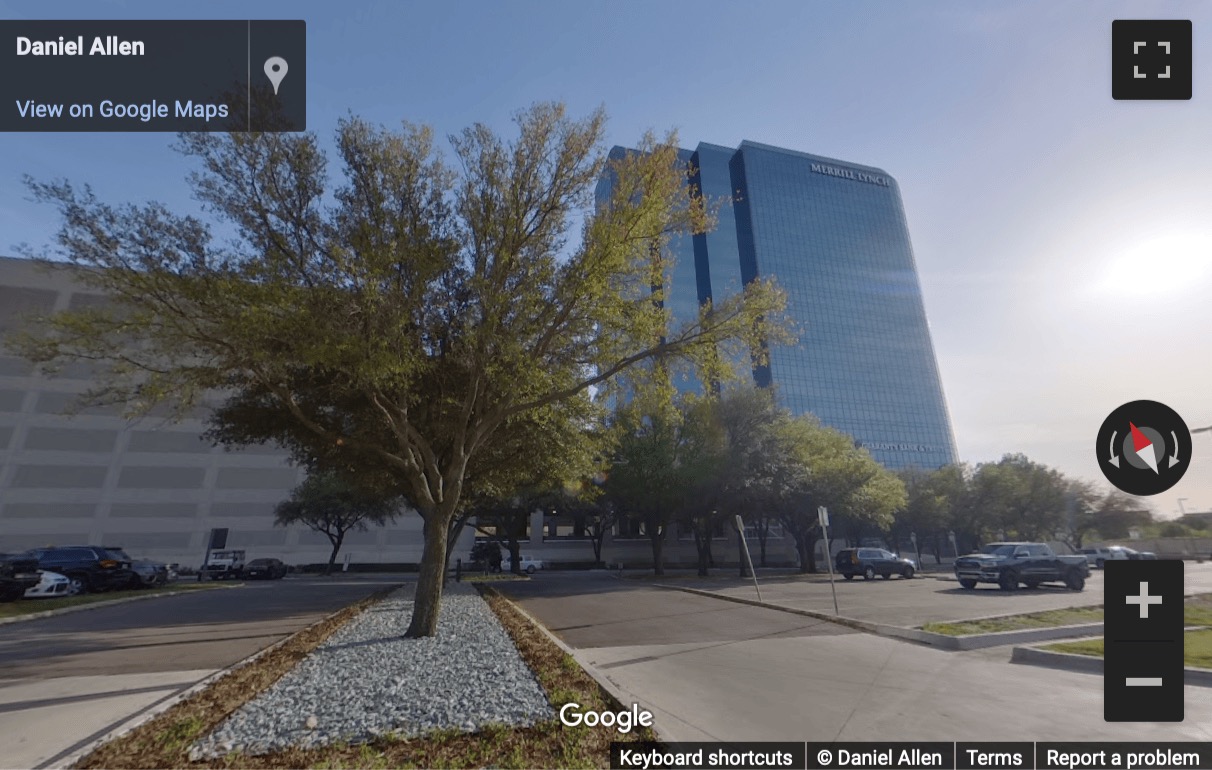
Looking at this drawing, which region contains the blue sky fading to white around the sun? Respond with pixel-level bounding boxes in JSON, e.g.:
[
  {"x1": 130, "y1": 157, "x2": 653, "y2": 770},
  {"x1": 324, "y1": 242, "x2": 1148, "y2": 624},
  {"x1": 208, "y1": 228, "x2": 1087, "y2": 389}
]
[{"x1": 0, "y1": 0, "x2": 1212, "y2": 515}]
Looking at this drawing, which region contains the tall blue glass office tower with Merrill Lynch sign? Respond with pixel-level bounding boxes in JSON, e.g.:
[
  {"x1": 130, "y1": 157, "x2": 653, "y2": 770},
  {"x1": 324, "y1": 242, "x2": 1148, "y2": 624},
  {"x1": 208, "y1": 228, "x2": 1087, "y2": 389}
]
[{"x1": 600, "y1": 142, "x2": 956, "y2": 469}]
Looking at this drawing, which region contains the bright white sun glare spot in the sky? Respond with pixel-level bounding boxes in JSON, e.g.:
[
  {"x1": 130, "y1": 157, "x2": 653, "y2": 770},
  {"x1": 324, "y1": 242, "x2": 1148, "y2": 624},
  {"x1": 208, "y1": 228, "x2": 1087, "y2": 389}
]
[{"x1": 1094, "y1": 232, "x2": 1212, "y2": 296}]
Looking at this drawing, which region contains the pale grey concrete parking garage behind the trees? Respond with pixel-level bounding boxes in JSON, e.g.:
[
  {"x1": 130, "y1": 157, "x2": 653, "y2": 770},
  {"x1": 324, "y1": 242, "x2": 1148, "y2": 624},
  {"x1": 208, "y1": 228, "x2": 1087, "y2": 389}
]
[{"x1": 0, "y1": 257, "x2": 814, "y2": 569}]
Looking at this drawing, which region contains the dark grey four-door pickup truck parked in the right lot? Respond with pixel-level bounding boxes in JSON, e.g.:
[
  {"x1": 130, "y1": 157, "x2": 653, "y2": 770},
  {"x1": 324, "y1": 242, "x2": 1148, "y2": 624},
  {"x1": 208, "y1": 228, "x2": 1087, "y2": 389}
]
[{"x1": 955, "y1": 543, "x2": 1090, "y2": 591}]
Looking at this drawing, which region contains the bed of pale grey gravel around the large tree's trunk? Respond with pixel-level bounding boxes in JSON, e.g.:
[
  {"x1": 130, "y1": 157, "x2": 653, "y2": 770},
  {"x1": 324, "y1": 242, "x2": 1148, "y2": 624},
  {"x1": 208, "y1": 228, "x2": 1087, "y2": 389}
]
[{"x1": 190, "y1": 583, "x2": 554, "y2": 760}]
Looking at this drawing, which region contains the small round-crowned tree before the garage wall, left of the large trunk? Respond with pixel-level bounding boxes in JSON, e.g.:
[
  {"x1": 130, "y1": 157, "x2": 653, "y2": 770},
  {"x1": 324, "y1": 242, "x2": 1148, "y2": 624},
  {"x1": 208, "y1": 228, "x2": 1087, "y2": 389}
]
[{"x1": 274, "y1": 474, "x2": 402, "y2": 575}]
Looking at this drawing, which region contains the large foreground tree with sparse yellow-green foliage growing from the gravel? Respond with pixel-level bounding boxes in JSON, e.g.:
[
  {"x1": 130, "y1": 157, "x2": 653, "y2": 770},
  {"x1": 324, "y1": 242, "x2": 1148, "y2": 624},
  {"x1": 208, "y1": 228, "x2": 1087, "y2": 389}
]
[{"x1": 17, "y1": 104, "x2": 784, "y2": 637}]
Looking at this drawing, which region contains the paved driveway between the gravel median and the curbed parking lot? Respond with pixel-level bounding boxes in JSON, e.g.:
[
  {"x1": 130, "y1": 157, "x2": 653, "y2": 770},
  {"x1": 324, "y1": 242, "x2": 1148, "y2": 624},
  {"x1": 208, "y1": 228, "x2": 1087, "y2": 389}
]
[{"x1": 499, "y1": 576, "x2": 1212, "y2": 742}]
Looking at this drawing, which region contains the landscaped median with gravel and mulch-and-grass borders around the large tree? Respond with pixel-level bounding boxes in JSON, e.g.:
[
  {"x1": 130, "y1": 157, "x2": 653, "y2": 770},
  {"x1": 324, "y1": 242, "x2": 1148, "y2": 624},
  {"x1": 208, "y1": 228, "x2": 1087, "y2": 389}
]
[{"x1": 68, "y1": 583, "x2": 654, "y2": 768}]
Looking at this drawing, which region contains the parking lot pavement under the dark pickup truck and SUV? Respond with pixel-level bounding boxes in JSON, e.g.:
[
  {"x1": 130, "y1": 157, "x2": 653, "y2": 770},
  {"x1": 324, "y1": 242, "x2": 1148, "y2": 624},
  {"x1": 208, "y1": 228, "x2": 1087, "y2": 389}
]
[{"x1": 653, "y1": 561, "x2": 1212, "y2": 627}]
